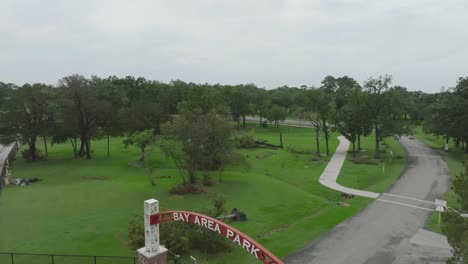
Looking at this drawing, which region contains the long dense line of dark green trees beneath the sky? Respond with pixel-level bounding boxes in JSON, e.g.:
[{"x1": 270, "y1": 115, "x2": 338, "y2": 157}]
[{"x1": 0, "y1": 74, "x2": 436, "y2": 161}]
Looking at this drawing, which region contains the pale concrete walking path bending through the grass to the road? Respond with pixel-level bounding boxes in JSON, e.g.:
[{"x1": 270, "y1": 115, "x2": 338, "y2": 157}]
[{"x1": 319, "y1": 136, "x2": 380, "y2": 199}]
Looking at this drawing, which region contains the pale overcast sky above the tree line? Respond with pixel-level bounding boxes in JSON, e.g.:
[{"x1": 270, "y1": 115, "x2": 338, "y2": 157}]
[{"x1": 0, "y1": 0, "x2": 468, "y2": 92}]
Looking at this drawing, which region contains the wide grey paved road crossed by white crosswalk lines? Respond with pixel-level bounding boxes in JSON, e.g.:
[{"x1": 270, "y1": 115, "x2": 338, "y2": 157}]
[{"x1": 285, "y1": 137, "x2": 450, "y2": 264}]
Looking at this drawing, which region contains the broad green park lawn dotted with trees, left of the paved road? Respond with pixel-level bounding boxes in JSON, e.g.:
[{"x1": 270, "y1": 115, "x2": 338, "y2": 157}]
[{"x1": 0, "y1": 124, "x2": 403, "y2": 263}]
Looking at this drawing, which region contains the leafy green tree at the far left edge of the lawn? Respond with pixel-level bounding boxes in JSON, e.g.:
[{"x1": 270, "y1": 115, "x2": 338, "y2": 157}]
[{"x1": 0, "y1": 83, "x2": 52, "y2": 161}]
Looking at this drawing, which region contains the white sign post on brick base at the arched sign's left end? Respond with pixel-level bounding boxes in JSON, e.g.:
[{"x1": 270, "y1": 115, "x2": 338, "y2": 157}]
[{"x1": 137, "y1": 199, "x2": 168, "y2": 264}]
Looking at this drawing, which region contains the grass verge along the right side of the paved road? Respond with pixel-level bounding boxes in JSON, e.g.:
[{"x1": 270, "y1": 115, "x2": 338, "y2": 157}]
[{"x1": 413, "y1": 127, "x2": 466, "y2": 233}]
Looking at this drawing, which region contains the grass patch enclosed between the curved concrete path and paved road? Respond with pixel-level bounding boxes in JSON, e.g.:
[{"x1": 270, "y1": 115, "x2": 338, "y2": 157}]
[{"x1": 337, "y1": 135, "x2": 406, "y2": 193}]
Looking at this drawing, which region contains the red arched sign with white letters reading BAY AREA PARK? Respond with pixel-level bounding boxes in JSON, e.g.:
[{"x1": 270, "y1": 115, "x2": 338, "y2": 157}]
[{"x1": 150, "y1": 211, "x2": 283, "y2": 264}]
